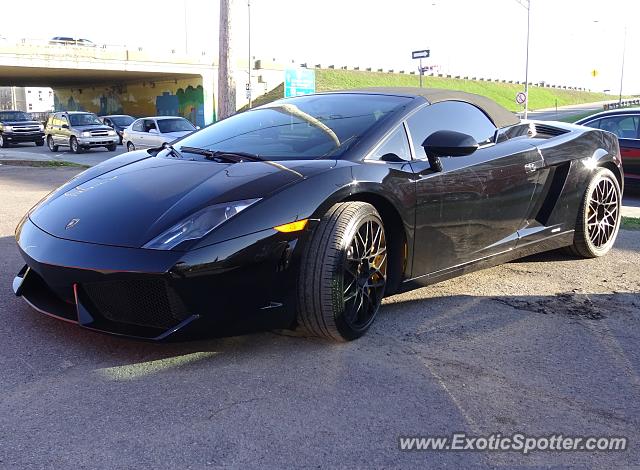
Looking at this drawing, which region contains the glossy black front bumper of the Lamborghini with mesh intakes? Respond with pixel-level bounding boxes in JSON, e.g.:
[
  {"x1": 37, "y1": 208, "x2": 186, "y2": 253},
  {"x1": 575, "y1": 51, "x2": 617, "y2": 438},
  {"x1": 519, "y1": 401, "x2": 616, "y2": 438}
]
[{"x1": 13, "y1": 219, "x2": 297, "y2": 340}]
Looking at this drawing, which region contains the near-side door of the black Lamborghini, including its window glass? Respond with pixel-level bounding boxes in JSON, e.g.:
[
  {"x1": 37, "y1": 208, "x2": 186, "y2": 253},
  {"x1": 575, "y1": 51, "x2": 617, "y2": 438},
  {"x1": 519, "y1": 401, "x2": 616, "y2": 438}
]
[{"x1": 407, "y1": 101, "x2": 543, "y2": 277}]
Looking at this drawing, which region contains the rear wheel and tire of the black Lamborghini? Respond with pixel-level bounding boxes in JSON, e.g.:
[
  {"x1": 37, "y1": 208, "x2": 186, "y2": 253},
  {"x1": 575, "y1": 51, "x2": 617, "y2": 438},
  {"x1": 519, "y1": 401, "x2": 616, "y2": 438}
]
[{"x1": 567, "y1": 168, "x2": 622, "y2": 258}]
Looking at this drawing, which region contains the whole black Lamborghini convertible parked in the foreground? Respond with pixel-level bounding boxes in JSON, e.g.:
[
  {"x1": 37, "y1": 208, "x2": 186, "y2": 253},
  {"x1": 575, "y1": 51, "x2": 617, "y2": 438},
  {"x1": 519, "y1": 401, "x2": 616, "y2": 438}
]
[{"x1": 13, "y1": 88, "x2": 623, "y2": 340}]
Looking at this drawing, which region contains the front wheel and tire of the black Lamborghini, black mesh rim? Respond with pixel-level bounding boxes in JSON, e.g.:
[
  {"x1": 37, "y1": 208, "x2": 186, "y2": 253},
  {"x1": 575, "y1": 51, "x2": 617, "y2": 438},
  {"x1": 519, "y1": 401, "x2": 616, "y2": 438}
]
[{"x1": 297, "y1": 202, "x2": 388, "y2": 341}]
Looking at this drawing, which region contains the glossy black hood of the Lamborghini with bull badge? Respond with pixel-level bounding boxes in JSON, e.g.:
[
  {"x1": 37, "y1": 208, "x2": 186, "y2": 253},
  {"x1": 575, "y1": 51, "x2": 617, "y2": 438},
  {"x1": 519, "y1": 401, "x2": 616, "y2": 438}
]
[{"x1": 29, "y1": 157, "x2": 336, "y2": 248}]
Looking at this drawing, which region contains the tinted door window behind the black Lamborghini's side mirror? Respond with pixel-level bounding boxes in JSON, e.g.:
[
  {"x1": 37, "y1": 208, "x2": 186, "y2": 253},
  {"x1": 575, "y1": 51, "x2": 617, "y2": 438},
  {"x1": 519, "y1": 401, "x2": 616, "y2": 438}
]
[{"x1": 407, "y1": 101, "x2": 497, "y2": 159}]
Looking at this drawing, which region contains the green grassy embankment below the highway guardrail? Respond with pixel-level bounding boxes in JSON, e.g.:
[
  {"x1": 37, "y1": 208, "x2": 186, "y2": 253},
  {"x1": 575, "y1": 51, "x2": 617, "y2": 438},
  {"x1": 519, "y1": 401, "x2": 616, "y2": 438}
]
[{"x1": 249, "y1": 69, "x2": 615, "y2": 111}]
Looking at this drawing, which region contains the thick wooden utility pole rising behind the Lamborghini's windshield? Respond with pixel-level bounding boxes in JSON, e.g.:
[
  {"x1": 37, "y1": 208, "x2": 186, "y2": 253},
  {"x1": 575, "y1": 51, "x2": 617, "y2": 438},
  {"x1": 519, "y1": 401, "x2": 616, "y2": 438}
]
[{"x1": 218, "y1": 0, "x2": 236, "y2": 119}]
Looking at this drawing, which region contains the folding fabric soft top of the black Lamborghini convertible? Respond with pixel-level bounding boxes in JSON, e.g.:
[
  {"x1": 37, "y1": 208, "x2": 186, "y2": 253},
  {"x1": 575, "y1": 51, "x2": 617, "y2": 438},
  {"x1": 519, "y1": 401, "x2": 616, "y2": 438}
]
[{"x1": 334, "y1": 87, "x2": 520, "y2": 128}]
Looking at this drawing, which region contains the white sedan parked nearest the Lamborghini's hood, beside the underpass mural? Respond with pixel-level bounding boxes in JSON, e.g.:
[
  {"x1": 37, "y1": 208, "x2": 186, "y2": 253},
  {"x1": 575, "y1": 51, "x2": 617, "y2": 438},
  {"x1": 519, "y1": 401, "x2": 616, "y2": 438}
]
[{"x1": 122, "y1": 116, "x2": 197, "y2": 152}]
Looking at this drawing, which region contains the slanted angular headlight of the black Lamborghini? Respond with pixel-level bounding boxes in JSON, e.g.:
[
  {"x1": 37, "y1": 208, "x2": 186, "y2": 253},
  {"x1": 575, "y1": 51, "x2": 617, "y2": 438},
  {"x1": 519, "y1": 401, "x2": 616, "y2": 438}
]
[{"x1": 143, "y1": 199, "x2": 260, "y2": 250}]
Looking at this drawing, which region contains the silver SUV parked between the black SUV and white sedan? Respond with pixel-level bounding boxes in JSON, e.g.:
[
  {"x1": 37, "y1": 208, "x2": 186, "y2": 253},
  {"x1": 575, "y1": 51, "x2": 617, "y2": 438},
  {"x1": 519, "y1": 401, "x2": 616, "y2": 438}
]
[{"x1": 44, "y1": 111, "x2": 120, "y2": 153}]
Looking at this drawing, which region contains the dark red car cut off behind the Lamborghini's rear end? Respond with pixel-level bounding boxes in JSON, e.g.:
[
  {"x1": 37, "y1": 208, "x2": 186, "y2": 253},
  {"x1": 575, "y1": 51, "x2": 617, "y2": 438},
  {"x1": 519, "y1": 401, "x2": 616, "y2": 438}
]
[{"x1": 576, "y1": 108, "x2": 640, "y2": 187}]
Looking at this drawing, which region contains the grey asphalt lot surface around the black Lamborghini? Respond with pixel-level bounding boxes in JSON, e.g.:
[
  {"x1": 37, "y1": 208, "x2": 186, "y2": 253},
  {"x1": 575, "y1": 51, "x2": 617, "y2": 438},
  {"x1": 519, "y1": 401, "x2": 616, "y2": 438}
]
[{"x1": 0, "y1": 164, "x2": 640, "y2": 468}]
